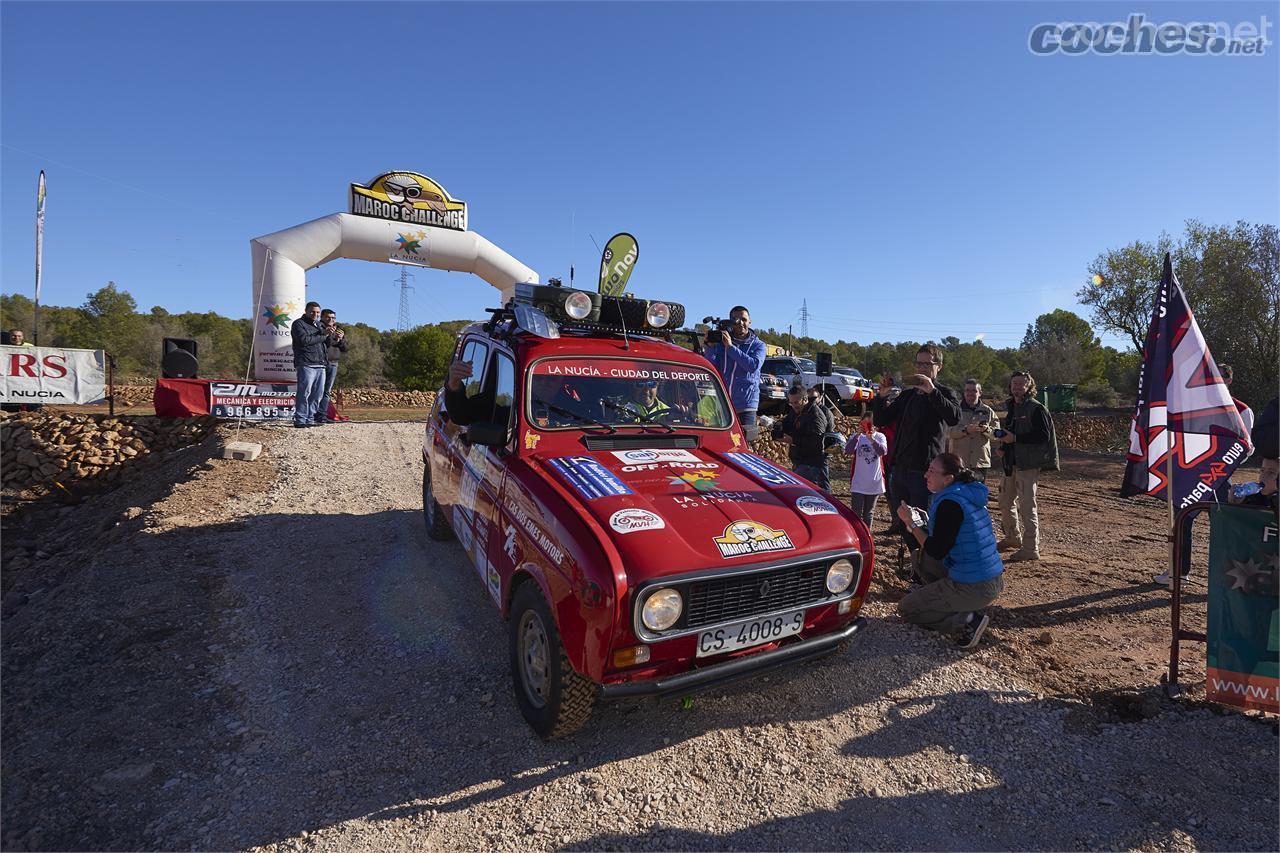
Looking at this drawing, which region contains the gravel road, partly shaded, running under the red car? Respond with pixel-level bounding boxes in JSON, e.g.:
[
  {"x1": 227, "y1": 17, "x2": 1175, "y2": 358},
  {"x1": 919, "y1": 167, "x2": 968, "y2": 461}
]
[{"x1": 0, "y1": 423, "x2": 1277, "y2": 850}]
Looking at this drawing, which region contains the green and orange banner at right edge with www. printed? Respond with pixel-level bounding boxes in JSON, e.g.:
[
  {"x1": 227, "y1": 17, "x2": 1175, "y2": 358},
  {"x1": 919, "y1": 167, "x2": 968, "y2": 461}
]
[{"x1": 1204, "y1": 506, "x2": 1280, "y2": 713}]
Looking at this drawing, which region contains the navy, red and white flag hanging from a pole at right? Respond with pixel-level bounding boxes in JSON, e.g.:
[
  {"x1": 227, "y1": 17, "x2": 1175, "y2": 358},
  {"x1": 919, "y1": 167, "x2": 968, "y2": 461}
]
[{"x1": 1120, "y1": 255, "x2": 1251, "y2": 508}]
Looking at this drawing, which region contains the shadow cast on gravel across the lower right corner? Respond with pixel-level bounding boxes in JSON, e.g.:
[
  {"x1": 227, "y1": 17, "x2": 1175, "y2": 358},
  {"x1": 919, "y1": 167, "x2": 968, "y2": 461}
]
[{"x1": 566, "y1": 690, "x2": 1276, "y2": 850}]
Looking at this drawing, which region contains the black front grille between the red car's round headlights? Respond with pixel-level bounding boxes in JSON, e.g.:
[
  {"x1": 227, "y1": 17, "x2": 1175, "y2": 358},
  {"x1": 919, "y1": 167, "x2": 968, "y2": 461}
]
[{"x1": 684, "y1": 562, "x2": 831, "y2": 629}]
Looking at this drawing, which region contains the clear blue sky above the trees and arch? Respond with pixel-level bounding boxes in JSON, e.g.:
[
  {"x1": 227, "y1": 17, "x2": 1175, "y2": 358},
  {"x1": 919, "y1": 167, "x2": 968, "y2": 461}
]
[{"x1": 0, "y1": 3, "x2": 1280, "y2": 346}]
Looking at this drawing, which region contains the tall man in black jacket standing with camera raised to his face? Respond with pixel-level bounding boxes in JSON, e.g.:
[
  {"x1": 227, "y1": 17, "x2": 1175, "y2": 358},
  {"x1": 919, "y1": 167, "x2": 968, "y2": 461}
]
[{"x1": 872, "y1": 343, "x2": 960, "y2": 526}]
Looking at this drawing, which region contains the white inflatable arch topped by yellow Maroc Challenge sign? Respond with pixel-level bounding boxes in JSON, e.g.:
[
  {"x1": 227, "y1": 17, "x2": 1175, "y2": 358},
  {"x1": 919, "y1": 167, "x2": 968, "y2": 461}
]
[{"x1": 250, "y1": 172, "x2": 539, "y2": 382}]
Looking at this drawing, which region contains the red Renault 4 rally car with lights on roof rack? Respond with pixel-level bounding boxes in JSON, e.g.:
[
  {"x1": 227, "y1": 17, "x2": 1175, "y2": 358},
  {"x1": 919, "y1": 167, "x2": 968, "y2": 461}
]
[{"x1": 422, "y1": 286, "x2": 873, "y2": 738}]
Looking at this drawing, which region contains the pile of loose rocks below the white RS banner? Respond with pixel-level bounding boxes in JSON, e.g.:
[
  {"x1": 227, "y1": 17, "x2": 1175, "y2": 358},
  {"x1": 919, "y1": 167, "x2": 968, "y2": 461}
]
[{"x1": 0, "y1": 412, "x2": 218, "y2": 489}]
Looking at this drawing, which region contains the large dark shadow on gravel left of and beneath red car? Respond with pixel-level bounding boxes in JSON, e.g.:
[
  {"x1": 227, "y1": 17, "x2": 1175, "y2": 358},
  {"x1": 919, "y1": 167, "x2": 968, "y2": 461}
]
[{"x1": 4, "y1": 510, "x2": 945, "y2": 849}]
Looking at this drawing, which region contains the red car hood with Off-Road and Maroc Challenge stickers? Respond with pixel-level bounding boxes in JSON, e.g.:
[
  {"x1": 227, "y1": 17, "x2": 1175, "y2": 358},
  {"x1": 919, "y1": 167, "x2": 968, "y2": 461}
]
[{"x1": 538, "y1": 448, "x2": 858, "y2": 583}]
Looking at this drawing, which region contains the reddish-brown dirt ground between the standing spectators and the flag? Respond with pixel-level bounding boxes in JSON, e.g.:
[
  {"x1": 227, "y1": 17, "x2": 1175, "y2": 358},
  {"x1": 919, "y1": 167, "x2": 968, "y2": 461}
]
[{"x1": 832, "y1": 451, "x2": 1213, "y2": 712}]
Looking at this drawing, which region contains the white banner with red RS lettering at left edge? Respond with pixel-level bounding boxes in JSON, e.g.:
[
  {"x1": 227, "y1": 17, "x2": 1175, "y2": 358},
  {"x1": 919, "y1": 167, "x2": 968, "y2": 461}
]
[{"x1": 0, "y1": 346, "x2": 106, "y2": 406}]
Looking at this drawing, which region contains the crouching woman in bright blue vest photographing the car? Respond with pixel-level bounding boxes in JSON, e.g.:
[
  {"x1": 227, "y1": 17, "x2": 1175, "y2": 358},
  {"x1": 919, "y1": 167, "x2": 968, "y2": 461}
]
[{"x1": 897, "y1": 453, "x2": 1005, "y2": 648}]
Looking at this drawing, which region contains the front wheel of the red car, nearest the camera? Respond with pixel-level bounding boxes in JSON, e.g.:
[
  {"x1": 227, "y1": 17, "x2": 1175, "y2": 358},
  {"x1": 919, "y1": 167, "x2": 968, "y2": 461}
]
[{"x1": 508, "y1": 581, "x2": 599, "y2": 740}]
